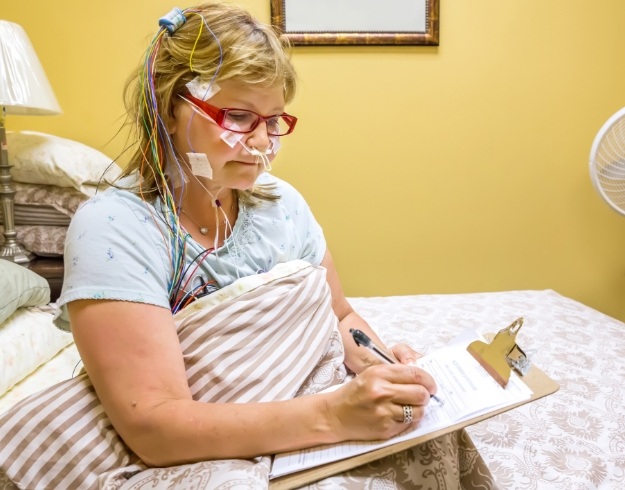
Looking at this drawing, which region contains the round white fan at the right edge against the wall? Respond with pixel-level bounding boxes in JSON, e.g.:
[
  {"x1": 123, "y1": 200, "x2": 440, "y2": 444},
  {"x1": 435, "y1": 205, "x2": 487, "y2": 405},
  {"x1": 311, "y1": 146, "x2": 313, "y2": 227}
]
[{"x1": 590, "y1": 107, "x2": 625, "y2": 216}]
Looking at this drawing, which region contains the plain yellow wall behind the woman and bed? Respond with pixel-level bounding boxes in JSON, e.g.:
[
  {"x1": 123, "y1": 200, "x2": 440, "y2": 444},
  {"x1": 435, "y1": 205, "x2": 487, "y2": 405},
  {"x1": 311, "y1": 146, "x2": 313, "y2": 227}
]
[{"x1": 1, "y1": 0, "x2": 625, "y2": 320}]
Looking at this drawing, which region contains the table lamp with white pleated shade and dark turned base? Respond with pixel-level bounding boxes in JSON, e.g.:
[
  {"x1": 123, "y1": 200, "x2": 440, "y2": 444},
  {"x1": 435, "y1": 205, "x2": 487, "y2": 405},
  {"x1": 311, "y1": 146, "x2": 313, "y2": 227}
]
[{"x1": 0, "y1": 20, "x2": 61, "y2": 263}]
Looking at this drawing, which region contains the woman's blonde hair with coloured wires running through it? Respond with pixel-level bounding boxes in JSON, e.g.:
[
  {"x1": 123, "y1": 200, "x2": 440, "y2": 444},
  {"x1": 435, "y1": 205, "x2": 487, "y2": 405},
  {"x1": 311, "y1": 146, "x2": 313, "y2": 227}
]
[{"x1": 123, "y1": 3, "x2": 296, "y2": 205}]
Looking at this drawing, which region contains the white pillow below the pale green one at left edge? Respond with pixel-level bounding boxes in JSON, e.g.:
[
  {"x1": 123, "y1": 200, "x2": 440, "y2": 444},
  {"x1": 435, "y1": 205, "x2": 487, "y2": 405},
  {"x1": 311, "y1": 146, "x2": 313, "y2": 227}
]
[{"x1": 0, "y1": 306, "x2": 73, "y2": 395}]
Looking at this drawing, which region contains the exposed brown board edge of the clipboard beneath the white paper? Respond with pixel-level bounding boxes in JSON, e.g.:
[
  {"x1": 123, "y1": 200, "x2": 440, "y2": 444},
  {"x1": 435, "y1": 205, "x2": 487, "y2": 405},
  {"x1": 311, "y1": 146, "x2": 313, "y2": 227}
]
[{"x1": 269, "y1": 344, "x2": 560, "y2": 490}]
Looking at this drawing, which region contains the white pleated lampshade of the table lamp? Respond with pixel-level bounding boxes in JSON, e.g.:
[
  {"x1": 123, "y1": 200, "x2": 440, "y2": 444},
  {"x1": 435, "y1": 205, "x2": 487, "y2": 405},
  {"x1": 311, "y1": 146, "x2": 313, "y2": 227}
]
[{"x1": 0, "y1": 20, "x2": 61, "y2": 115}]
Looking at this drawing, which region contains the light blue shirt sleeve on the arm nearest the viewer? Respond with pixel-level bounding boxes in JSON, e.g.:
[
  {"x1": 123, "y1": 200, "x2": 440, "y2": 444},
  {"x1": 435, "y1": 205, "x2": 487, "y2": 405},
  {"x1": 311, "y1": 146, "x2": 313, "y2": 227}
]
[{"x1": 55, "y1": 192, "x2": 171, "y2": 330}]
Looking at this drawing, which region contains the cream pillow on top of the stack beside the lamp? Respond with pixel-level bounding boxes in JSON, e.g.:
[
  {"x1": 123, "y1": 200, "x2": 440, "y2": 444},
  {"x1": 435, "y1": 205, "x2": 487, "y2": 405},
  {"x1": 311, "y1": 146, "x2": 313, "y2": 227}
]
[{"x1": 7, "y1": 131, "x2": 120, "y2": 191}]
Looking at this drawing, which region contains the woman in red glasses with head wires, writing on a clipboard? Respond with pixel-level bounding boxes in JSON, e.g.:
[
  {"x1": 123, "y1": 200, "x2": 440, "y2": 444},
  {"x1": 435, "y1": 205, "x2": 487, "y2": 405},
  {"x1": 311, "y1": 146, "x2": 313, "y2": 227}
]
[{"x1": 1, "y1": 3, "x2": 498, "y2": 488}]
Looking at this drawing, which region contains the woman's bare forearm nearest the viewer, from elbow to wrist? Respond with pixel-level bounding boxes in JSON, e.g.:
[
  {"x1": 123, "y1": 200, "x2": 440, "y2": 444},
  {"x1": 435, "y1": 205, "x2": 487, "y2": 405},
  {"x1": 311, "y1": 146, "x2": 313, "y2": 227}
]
[{"x1": 124, "y1": 394, "x2": 341, "y2": 466}]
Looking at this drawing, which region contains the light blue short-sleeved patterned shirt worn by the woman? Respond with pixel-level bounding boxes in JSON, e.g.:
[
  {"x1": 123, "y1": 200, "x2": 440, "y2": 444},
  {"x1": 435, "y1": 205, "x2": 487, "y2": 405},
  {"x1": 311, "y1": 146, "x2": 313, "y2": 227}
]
[{"x1": 55, "y1": 174, "x2": 326, "y2": 330}]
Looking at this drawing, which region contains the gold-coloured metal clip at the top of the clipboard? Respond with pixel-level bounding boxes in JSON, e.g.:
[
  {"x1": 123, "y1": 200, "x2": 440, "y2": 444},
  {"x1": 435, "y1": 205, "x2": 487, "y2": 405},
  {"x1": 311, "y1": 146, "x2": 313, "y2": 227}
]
[{"x1": 467, "y1": 318, "x2": 532, "y2": 388}]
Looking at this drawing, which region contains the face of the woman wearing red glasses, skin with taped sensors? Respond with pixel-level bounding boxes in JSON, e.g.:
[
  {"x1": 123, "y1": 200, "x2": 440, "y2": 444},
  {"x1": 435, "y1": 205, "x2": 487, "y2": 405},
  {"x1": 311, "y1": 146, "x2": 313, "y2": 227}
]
[{"x1": 169, "y1": 80, "x2": 284, "y2": 190}]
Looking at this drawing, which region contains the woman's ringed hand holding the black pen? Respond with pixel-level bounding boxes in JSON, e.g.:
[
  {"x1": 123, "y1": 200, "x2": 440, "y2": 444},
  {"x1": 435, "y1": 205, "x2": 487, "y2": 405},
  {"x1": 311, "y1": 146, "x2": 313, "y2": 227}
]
[{"x1": 328, "y1": 364, "x2": 436, "y2": 440}]
